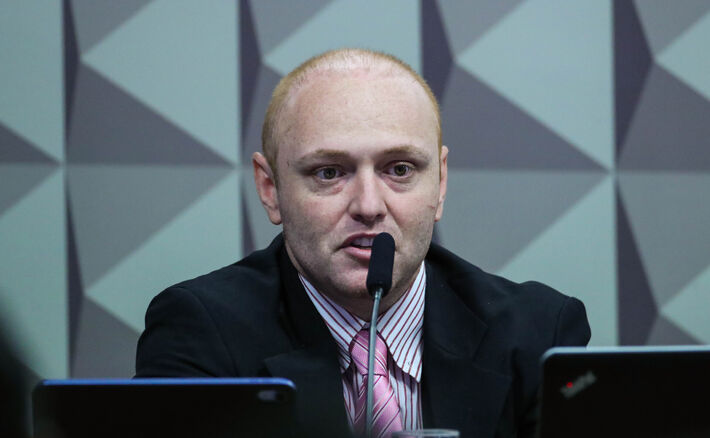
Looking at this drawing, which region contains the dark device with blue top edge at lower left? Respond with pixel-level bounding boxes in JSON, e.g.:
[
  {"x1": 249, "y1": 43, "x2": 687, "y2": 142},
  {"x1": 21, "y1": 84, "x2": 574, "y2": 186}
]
[{"x1": 32, "y1": 378, "x2": 295, "y2": 438}]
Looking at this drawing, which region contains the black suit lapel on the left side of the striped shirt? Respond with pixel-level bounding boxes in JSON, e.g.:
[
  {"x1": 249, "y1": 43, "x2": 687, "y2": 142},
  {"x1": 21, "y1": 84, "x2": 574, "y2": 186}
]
[{"x1": 264, "y1": 251, "x2": 350, "y2": 437}]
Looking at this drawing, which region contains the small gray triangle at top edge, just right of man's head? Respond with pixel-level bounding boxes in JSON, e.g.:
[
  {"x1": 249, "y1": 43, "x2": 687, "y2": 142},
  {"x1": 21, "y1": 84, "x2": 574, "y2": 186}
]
[{"x1": 438, "y1": 0, "x2": 522, "y2": 54}]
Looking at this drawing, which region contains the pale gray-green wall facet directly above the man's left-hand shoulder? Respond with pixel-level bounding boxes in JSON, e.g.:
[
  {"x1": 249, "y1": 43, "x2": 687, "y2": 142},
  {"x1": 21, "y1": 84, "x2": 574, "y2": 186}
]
[{"x1": 87, "y1": 170, "x2": 242, "y2": 332}]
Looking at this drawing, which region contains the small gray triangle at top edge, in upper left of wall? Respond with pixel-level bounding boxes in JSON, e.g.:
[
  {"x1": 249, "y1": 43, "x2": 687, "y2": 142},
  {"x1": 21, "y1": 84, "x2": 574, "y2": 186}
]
[{"x1": 71, "y1": 0, "x2": 150, "y2": 53}]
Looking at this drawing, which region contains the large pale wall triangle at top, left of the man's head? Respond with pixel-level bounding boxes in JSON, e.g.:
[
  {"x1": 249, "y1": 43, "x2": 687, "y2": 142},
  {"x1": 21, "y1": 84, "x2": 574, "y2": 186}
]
[{"x1": 82, "y1": 0, "x2": 240, "y2": 163}]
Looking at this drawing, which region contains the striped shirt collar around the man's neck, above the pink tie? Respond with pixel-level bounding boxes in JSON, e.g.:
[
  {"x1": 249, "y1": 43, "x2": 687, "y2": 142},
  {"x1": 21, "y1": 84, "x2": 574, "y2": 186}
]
[{"x1": 298, "y1": 262, "x2": 426, "y2": 382}]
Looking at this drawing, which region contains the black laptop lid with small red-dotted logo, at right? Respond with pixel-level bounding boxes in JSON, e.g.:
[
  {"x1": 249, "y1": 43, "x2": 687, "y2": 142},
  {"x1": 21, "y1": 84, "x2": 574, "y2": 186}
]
[{"x1": 539, "y1": 346, "x2": 710, "y2": 438}]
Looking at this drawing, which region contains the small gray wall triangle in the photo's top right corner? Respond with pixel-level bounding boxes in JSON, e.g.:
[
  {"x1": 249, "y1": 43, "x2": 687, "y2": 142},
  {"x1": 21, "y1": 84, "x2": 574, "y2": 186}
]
[{"x1": 636, "y1": 0, "x2": 710, "y2": 54}]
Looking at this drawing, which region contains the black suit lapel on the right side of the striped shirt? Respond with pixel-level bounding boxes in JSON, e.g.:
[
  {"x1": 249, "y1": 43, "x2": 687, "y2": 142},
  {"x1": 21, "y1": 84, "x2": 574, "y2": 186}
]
[{"x1": 422, "y1": 266, "x2": 511, "y2": 437}]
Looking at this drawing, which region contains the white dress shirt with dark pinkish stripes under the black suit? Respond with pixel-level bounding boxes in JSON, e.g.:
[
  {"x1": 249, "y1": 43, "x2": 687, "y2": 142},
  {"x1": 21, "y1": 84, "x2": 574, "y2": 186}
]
[{"x1": 298, "y1": 262, "x2": 426, "y2": 429}]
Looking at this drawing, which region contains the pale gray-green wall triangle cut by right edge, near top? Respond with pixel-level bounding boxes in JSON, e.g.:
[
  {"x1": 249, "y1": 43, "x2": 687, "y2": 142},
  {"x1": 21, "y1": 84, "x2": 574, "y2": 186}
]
[{"x1": 656, "y1": 12, "x2": 710, "y2": 100}]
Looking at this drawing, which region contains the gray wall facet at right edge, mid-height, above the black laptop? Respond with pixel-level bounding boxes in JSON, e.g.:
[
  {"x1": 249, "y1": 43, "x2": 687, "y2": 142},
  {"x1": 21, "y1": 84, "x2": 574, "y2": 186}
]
[{"x1": 619, "y1": 172, "x2": 710, "y2": 308}]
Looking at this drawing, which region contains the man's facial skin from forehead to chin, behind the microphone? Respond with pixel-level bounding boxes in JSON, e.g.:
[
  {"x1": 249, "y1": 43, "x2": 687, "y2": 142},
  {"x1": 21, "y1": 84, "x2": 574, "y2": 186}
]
[{"x1": 277, "y1": 73, "x2": 440, "y2": 319}]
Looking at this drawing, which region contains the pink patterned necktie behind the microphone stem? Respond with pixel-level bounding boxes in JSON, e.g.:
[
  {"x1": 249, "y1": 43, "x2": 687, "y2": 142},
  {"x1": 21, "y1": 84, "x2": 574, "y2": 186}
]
[{"x1": 350, "y1": 329, "x2": 402, "y2": 438}]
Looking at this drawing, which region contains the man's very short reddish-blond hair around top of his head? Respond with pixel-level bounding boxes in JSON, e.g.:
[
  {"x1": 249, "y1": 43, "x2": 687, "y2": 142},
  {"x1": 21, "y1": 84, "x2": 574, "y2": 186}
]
[{"x1": 261, "y1": 49, "x2": 442, "y2": 178}]
